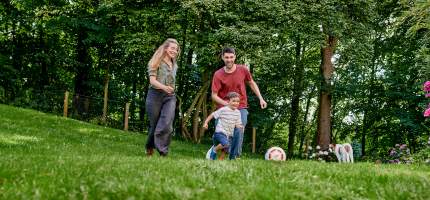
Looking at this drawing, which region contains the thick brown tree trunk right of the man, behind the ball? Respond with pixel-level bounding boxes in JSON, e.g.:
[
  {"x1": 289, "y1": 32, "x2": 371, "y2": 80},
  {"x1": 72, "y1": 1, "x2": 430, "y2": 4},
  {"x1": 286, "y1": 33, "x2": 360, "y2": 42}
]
[{"x1": 317, "y1": 36, "x2": 337, "y2": 150}]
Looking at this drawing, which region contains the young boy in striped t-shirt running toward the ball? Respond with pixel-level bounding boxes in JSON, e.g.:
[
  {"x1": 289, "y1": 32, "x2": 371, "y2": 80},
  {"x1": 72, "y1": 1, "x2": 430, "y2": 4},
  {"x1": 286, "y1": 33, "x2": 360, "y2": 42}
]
[{"x1": 203, "y1": 92, "x2": 243, "y2": 160}]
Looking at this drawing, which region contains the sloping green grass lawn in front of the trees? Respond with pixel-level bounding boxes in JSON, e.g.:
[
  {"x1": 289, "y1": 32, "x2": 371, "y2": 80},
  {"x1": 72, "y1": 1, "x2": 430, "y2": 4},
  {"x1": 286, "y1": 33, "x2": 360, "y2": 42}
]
[{"x1": 0, "y1": 105, "x2": 430, "y2": 199}]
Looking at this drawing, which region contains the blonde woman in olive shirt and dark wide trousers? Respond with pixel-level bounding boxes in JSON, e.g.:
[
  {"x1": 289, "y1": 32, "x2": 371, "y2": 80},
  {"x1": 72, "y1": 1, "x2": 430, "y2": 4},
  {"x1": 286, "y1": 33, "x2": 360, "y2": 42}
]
[{"x1": 146, "y1": 38, "x2": 180, "y2": 156}]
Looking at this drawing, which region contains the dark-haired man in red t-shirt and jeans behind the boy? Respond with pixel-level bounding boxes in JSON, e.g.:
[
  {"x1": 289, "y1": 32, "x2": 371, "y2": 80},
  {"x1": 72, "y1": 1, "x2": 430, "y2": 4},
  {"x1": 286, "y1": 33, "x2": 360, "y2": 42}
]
[{"x1": 212, "y1": 47, "x2": 267, "y2": 160}]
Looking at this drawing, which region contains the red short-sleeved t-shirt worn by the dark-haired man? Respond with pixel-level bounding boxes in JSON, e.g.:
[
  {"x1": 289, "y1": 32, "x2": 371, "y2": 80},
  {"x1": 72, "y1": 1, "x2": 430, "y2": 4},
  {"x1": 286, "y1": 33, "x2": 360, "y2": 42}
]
[{"x1": 212, "y1": 65, "x2": 252, "y2": 109}]
